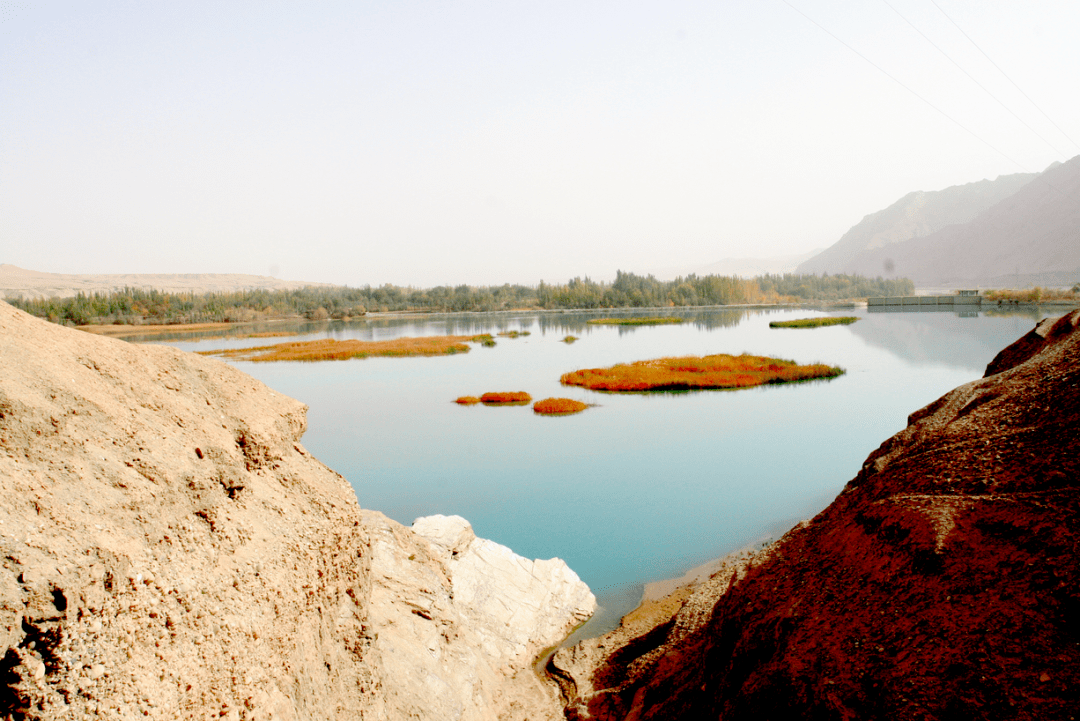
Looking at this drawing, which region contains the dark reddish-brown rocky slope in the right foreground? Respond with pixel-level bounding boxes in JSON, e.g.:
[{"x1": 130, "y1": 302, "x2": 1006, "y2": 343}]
[{"x1": 554, "y1": 311, "x2": 1080, "y2": 720}]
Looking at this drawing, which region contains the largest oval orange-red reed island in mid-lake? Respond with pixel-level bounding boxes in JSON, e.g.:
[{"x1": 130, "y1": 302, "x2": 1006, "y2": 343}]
[{"x1": 559, "y1": 354, "x2": 843, "y2": 392}]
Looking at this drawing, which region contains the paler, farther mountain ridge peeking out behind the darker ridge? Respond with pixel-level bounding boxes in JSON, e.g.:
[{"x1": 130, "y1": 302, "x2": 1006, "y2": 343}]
[{"x1": 797, "y1": 170, "x2": 1036, "y2": 283}]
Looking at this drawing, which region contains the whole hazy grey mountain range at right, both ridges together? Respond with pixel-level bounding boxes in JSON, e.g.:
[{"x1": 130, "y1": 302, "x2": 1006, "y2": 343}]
[{"x1": 797, "y1": 157, "x2": 1080, "y2": 287}]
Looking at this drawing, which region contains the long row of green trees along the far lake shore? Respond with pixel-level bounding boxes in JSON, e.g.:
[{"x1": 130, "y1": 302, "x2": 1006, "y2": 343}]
[{"x1": 9, "y1": 271, "x2": 914, "y2": 325}]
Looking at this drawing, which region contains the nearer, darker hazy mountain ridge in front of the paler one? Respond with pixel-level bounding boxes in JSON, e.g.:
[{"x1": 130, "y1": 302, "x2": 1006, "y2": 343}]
[{"x1": 816, "y1": 155, "x2": 1080, "y2": 287}]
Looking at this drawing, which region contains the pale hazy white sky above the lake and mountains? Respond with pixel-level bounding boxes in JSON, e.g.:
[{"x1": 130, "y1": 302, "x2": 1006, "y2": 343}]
[{"x1": 0, "y1": 0, "x2": 1080, "y2": 287}]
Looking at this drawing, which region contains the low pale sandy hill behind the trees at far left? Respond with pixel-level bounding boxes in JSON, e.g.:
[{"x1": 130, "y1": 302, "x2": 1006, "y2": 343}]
[{"x1": 0, "y1": 263, "x2": 330, "y2": 299}]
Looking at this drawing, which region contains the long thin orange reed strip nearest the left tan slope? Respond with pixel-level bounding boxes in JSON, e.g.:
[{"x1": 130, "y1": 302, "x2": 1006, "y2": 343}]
[{"x1": 197, "y1": 335, "x2": 495, "y2": 363}]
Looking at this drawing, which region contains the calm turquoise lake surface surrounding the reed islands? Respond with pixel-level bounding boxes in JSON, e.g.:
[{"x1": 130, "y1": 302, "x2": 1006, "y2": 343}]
[{"x1": 156, "y1": 309, "x2": 1061, "y2": 632}]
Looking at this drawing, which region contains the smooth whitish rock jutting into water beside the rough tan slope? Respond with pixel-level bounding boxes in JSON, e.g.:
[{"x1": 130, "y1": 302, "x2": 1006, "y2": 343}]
[{"x1": 362, "y1": 511, "x2": 596, "y2": 721}]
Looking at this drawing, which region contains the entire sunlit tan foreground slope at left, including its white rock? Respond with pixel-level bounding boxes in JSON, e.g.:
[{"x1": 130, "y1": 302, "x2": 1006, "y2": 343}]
[{"x1": 0, "y1": 303, "x2": 594, "y2": 720}]
